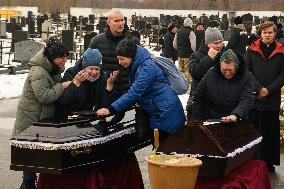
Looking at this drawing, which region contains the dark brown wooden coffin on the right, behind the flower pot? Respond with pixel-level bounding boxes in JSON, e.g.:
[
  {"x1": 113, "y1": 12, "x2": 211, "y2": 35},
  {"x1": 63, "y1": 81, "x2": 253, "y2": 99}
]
[{"x1": 158, "y1": 122, "x2": 262, "y2": 177}]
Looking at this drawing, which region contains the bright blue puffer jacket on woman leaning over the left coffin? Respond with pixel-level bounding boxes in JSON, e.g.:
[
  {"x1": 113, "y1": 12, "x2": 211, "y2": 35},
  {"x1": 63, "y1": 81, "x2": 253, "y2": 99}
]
[{"x1": 111, "y1": 46, "x2": 185, "y2": 133}]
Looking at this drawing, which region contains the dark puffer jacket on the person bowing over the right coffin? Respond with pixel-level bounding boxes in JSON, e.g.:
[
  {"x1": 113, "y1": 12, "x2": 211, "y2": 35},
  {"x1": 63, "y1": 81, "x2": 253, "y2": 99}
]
[{"x1": 190, "y1": 51, "x2": 254, "y2": 120}]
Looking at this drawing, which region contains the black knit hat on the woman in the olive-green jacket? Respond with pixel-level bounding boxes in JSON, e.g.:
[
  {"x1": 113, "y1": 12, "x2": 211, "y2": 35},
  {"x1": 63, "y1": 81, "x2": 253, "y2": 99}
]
[{"x1": 43, "y1": 39, "x2": 69, "y2": 63}]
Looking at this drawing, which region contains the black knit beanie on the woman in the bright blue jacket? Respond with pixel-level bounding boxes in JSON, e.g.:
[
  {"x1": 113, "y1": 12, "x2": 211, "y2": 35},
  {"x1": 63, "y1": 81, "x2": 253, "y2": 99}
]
[{"x1": 116, "y1": 39, "x2": 137, "y2": 58}]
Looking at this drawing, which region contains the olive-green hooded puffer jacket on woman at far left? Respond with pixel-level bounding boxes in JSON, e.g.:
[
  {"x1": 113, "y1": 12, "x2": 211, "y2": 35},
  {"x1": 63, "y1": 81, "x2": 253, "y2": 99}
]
[{"x1": 13, "y1": 49, "x2": 64, "y2": 136}]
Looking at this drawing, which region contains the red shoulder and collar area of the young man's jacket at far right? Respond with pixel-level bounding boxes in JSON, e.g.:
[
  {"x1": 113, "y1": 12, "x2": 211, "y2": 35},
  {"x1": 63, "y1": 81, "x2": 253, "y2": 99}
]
[{"x1": 249, "y1": 39, "x2": 284, "y2": 60}]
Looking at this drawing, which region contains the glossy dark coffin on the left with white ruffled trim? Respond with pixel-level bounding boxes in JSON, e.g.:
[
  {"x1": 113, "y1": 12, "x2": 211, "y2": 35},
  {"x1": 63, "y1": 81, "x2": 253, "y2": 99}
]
[{"x1": 10, "y1": 110, "x2": 151, "y2": 174}]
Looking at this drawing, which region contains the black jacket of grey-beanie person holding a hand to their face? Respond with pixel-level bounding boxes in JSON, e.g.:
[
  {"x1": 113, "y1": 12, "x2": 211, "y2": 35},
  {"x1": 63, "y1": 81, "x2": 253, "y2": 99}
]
[{"x1": 189, "y1": 43, "x2": 214, "y2": 95}]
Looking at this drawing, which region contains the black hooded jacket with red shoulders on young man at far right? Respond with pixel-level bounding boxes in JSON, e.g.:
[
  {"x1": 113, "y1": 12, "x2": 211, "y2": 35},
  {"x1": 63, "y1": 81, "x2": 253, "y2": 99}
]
[{"x1": 245, "y1": 39, "x2": 284, "y2": 111}]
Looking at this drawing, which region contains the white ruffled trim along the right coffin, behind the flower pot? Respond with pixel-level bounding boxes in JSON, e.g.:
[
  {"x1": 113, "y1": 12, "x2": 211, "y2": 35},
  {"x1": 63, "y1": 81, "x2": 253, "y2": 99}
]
[{"x1": 166, "y1": 136, "x2": 262, "y2": 158}]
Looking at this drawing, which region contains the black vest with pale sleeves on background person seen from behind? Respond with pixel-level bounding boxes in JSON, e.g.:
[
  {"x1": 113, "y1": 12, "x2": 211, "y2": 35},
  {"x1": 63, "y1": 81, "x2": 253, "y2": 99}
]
[{"x1": 177, "y1": 26, "x2": 193, "y2": 58}]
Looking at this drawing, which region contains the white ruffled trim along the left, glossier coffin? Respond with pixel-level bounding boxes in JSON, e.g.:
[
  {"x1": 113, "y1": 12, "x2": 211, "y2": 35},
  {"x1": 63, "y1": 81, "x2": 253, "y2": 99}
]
[{"x1": 10, "y1": 127, "x2": 136, "y2": 150}]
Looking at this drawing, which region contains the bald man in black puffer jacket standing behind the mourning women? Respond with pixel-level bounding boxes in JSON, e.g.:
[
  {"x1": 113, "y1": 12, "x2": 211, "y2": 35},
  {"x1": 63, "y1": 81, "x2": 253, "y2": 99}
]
[{"x1": 89, "y1": 10, "x2": 139, "y2": 96}]
